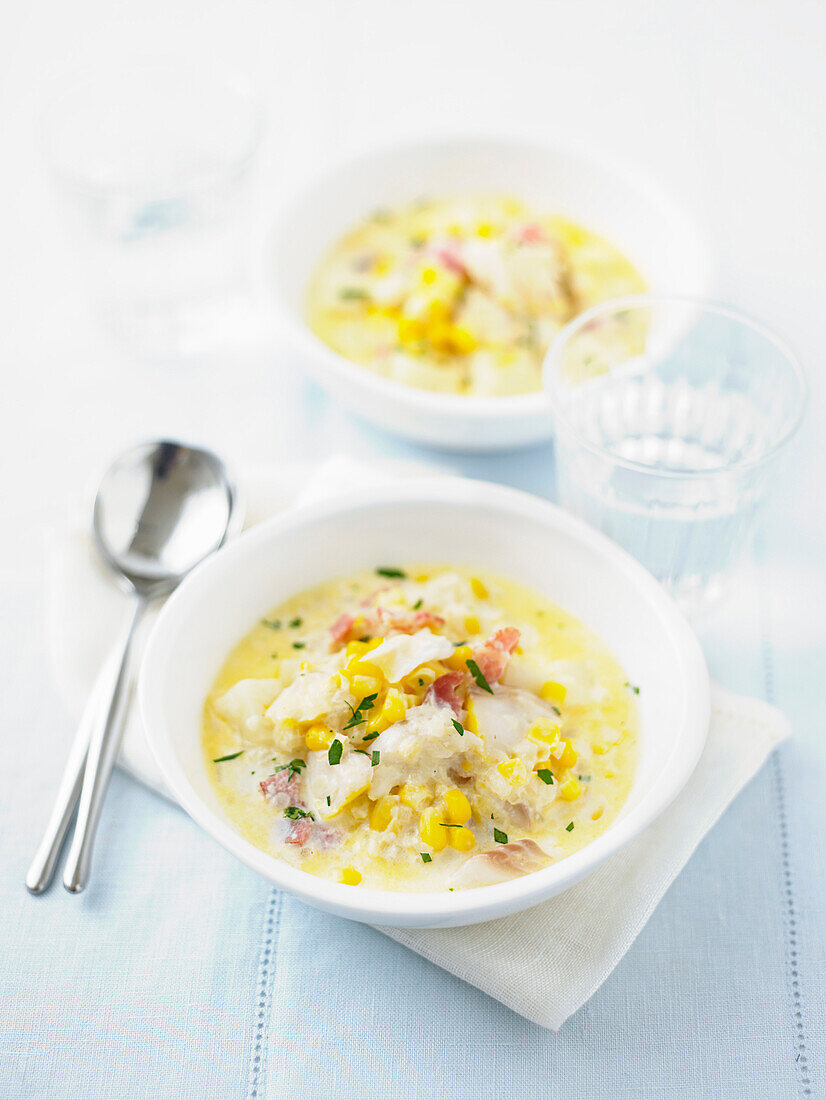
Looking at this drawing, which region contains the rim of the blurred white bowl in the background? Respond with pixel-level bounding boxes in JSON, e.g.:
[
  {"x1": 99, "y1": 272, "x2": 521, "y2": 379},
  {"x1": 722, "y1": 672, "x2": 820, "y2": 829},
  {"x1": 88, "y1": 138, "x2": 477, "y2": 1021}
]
[{"x1": 258, "y1": 132, "x2": 711, "y2": 424}]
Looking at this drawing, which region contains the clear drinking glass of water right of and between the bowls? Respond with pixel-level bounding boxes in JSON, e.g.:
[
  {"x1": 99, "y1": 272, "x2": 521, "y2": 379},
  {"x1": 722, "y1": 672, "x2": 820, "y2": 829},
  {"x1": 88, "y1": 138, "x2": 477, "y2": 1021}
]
[{"x1": 544, "y1": 295, "x2": 807, "y2": 615}]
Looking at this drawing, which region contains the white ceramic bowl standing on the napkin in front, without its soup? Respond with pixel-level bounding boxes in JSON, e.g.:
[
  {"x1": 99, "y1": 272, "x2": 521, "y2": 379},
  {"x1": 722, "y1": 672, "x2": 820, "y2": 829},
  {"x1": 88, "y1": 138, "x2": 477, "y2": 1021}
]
[{"x1": 140, "y1": 477, "x2": 709, "y2": 927}]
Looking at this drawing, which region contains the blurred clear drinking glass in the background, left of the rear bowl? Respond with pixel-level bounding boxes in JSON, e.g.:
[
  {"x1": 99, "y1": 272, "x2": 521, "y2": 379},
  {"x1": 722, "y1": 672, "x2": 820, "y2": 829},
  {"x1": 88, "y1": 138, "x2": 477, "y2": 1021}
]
[{"x1": 43, "y1": 59, "x2": 264, "y2": 358}]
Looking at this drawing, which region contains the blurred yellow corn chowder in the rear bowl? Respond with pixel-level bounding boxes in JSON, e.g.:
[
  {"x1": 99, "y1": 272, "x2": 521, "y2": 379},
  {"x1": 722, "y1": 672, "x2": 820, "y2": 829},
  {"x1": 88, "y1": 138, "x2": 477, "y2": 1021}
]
[{"x1": 308, "y1": 198, "x2": 646, "y2": 396}]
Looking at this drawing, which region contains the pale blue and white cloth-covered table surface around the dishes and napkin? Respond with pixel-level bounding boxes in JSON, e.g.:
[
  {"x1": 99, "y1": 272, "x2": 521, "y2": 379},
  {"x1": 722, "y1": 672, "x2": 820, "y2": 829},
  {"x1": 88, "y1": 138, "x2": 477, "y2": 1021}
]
[{"x1": 0, "y1": 0, "x2": 826, "y2": 1100}]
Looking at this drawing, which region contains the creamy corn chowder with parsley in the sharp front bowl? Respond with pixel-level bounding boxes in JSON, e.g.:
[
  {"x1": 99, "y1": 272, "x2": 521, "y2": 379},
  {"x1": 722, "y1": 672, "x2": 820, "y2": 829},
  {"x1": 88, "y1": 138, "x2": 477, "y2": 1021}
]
[{"x1": 203, "y1": 568, "x2": 637, "y2": 890}]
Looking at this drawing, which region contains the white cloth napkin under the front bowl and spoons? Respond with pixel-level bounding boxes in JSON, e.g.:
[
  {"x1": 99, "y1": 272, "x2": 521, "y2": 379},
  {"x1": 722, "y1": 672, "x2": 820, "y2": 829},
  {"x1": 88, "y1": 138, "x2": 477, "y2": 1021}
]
[{"x1": 48, "y1": 458, "x2": 790, "y2": 1029}]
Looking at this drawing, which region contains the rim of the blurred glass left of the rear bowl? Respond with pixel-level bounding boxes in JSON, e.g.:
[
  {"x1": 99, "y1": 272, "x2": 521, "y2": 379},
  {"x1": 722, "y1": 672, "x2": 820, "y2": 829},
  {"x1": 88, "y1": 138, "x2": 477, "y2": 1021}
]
[{"x1": 40, "y1": 56, "x2": 266, "y2": 197}]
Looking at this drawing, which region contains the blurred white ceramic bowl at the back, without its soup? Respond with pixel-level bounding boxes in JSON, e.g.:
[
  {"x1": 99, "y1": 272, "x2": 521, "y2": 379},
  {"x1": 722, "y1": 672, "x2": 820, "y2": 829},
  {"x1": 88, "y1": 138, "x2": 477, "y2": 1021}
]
[{"x1": 262, "y1": 139, "x2": 708, "y2": 451}]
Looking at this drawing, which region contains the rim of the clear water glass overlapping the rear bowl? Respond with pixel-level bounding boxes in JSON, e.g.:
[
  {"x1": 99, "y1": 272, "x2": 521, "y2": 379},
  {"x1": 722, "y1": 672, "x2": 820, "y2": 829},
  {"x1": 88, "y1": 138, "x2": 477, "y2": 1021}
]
[{"x1": 542, "y1": 294, "x2": 808, "y2": 481}]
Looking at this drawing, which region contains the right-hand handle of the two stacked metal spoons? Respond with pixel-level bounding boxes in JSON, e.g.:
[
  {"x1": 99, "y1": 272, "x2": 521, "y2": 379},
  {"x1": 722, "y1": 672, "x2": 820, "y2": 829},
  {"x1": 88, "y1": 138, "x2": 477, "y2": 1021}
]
[{"x1": 63, "y1": 596, "x2": 146, "y2": 893}]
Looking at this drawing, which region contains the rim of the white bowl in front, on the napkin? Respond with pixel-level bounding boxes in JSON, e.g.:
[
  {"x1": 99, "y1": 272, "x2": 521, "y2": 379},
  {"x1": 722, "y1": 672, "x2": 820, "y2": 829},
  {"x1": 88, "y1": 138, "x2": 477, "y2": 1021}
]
[{"x1": 139, "y1": 477, "x2": 711, "y2": 927}]
